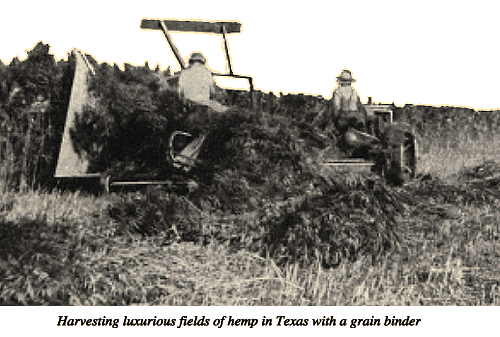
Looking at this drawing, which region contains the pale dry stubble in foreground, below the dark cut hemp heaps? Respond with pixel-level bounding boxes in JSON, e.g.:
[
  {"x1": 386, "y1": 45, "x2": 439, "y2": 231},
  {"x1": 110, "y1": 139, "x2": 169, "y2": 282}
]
[{"x1": 0, "y1": 175, "x2": 500, "y2": 305}]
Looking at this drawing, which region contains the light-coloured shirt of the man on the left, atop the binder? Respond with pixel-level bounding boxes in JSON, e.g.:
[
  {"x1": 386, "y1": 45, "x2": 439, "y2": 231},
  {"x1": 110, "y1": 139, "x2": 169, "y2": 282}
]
[{"x1": 179, "y1": 63, "x2": 215, "y2": 104}]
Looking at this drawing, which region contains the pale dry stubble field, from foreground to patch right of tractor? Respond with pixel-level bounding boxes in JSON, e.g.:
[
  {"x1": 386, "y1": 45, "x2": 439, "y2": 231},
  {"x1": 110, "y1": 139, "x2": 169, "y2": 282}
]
[{"x1": 0, "y1": 108, "x2": 500, "y2": 306}]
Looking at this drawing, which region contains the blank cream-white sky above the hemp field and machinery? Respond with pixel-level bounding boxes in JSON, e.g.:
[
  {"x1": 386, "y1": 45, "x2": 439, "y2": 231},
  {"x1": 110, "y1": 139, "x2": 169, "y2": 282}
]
[{"x1": 0, "y1": 0, "x2": 500, "y2": 110}]
